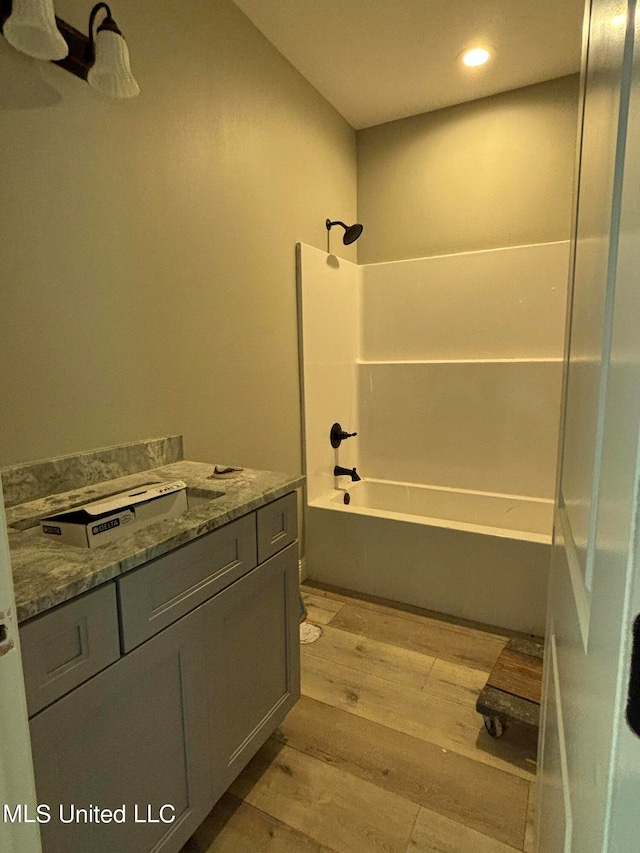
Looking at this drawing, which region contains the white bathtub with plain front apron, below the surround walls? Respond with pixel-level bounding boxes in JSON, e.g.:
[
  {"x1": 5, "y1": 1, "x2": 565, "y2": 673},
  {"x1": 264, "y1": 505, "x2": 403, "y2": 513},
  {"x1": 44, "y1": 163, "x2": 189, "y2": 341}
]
[{"x1": 306, "y1": 479, "x2": 553, "y2": 635}]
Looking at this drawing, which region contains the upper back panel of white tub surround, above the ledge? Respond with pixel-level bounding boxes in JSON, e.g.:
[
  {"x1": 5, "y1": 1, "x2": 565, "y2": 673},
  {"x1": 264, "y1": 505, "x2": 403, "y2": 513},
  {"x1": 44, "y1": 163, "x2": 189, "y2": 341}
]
[{"x1": 361, "y1": 241, "x2": 569, "y2": 361}]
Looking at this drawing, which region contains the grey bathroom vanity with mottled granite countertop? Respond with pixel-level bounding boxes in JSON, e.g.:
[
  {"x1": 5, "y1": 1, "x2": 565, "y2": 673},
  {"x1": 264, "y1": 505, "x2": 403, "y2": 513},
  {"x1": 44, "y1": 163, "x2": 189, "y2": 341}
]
[{"x1": 2, "y1": 440, "x2": 301, "y2": 853}]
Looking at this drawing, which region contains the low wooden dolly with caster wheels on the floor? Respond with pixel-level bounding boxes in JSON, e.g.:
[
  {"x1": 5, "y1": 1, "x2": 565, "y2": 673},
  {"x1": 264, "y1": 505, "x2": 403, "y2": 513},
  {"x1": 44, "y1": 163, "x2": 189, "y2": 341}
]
[{"x1": 476, "y1": 637, "x2": 544, "y2": 737}]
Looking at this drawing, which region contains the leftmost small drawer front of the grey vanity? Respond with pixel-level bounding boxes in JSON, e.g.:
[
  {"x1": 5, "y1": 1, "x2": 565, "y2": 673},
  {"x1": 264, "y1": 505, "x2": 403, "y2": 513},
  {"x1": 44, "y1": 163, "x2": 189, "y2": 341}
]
[{"x1": 20, "y1": 583, "x2": 120, "y2": 716}]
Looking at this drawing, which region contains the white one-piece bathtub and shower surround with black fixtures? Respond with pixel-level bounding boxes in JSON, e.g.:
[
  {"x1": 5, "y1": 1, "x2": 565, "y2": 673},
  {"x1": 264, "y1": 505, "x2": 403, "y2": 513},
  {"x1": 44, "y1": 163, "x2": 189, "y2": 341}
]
[{"x1": 298, "y1": 242, "x2": 569, "y2": 633}]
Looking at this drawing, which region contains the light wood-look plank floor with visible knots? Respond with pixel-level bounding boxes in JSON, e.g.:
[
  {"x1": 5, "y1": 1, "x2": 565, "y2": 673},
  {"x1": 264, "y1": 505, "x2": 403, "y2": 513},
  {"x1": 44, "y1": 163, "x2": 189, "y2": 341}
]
[{"x1": 183, "y1": 586, "x2": 536, "y2": 853}]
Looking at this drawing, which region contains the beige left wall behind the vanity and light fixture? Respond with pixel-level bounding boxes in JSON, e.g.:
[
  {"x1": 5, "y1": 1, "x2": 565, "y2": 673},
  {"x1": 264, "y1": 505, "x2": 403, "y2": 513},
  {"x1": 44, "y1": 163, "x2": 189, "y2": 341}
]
[{"x1": 0, "y1": 0, "x2": 356, "y2": 471}]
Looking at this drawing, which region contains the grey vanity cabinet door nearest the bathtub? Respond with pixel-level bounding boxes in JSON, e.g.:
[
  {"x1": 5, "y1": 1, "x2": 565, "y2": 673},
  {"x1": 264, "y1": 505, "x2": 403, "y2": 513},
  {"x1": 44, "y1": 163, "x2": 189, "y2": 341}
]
[{"x1": 202, "y1": 544, "x2": 300, "y2": 800}]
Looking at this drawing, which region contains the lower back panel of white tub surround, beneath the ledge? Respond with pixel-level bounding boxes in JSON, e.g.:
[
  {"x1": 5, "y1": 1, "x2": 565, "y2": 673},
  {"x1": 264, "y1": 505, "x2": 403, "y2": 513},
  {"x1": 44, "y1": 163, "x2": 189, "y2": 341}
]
[{"x1": 358, "y1": 358, "x2": 562, "y2": 492}]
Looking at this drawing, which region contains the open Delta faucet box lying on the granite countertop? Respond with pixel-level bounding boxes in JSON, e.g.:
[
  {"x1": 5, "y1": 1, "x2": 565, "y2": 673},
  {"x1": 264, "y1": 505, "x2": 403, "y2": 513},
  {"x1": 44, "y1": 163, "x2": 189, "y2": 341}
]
[{"x1": 40, "y1": 480, "x2": 187, "y2": 548}]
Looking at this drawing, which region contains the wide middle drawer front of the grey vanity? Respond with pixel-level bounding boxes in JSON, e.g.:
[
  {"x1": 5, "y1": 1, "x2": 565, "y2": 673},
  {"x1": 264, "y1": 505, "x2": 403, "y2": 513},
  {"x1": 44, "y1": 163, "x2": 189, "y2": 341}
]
[{"x1": 117, "y1": 513, "x2": 257, "y2": 652}]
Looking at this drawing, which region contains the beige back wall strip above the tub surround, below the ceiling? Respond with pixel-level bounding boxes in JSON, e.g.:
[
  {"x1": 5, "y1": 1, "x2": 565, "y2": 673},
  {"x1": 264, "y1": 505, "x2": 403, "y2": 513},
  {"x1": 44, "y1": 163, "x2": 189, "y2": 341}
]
[{"x1": 357, "y1": 75, "x2": 578, "y2": 263}]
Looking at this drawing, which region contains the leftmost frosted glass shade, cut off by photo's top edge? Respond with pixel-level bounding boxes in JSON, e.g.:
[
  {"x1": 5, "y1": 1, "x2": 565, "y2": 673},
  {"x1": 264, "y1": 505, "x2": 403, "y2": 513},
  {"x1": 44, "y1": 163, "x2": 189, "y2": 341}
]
[{"x1": 2, "y1": 0, "x2": 69, "y2": 59}]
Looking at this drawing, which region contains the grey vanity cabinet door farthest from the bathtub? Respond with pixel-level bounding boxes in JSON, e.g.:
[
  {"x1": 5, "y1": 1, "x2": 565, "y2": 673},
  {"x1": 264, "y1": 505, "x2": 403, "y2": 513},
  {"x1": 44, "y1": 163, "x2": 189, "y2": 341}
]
[{"x1": 31, "y1": 610, "x2": 212, "y2": 853}]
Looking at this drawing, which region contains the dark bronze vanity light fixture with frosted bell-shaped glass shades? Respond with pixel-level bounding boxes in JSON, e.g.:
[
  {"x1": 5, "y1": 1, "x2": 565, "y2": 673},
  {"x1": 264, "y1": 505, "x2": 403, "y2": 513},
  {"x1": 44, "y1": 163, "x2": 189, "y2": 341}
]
[{"x1": 0, "y1": 0, "x2": 140, "y2": 98}]
